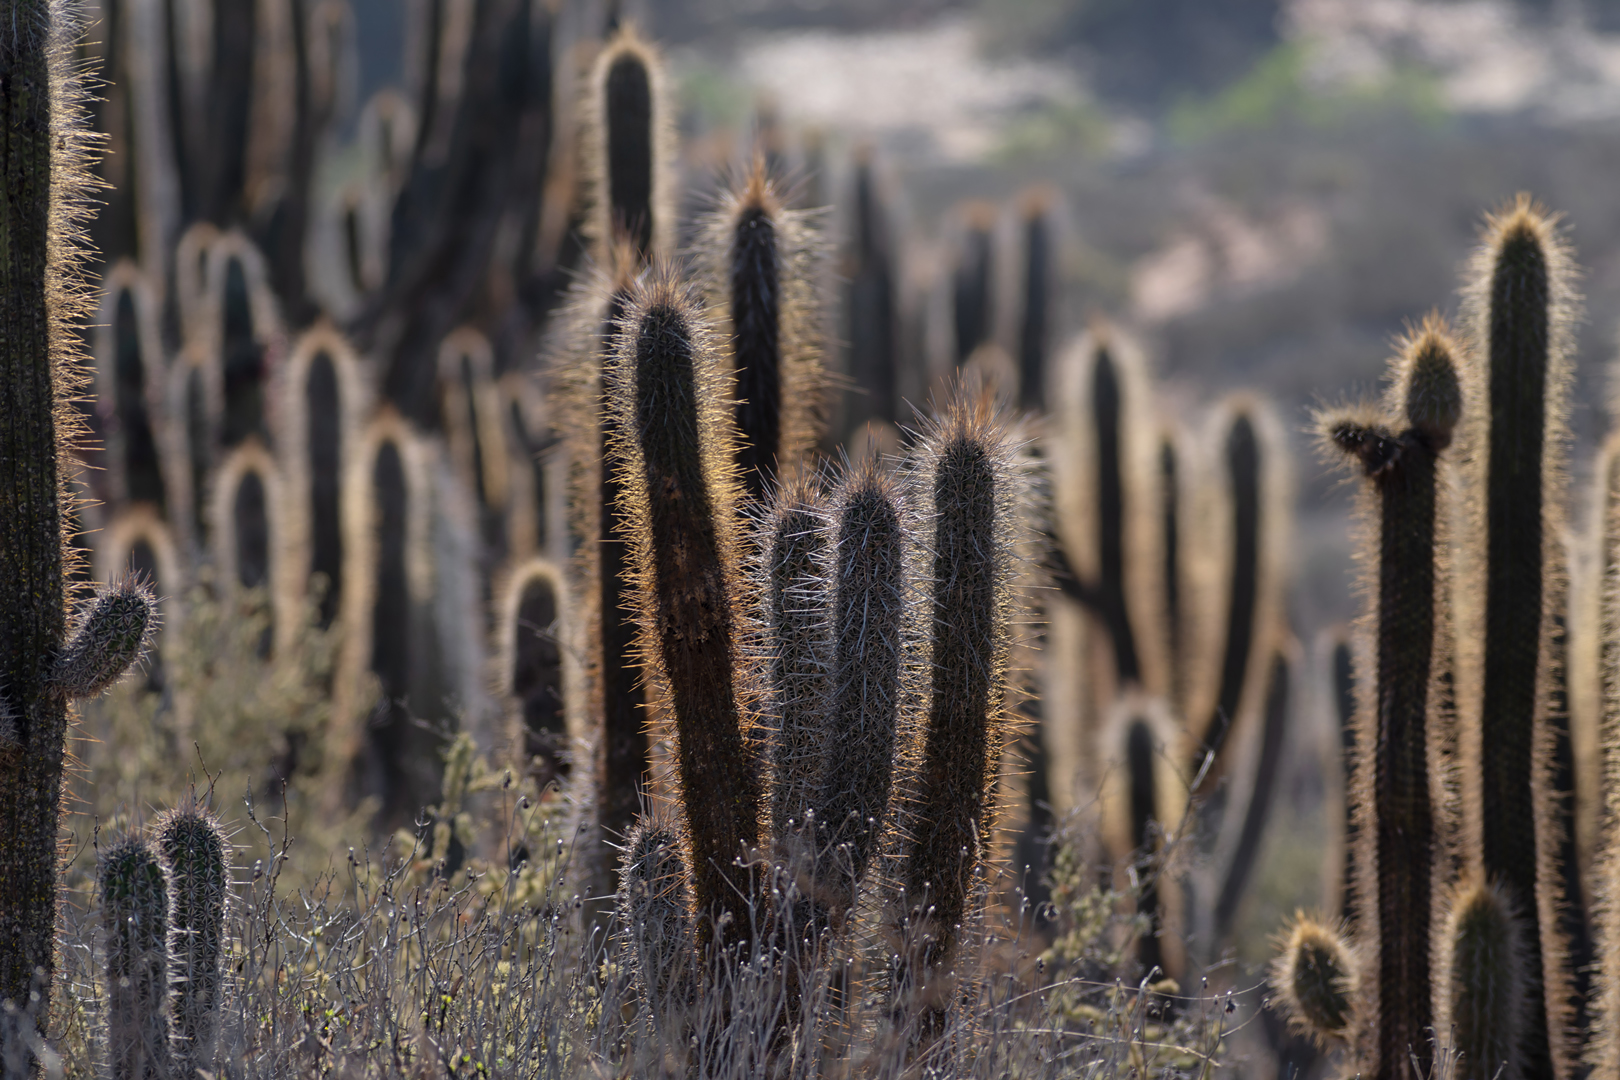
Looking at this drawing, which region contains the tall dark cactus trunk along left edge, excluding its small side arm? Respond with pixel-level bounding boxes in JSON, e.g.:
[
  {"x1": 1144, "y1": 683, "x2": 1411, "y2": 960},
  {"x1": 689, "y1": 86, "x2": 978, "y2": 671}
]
[{"x1": 0, "y1": 0, "x2": 97, "y2": 1042}]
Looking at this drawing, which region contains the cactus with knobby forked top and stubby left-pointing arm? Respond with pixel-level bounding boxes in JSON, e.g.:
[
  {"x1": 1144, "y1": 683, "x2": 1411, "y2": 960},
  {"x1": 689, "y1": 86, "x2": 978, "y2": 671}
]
[{"x1": 1322, "y1": 319, "x2": 1464, "y2": 1080}]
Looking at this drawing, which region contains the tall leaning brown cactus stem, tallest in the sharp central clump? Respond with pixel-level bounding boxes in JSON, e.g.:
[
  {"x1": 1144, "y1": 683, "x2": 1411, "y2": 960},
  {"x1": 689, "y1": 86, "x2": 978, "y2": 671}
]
[{"x1": 604, "y1": 267, "x2": 763, "y2": 950}]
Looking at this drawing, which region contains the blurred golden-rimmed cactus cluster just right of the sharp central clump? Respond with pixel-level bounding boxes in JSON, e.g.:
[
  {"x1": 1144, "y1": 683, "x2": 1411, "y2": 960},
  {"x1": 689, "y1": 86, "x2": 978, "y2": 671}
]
[{"x1": 1045, "y1": 324, "x2": 1293, "y2": 976}]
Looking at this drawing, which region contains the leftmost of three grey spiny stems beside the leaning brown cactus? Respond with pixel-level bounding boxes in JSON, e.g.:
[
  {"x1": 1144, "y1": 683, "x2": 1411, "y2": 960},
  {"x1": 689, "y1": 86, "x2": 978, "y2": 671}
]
[{"x1": 760, "y1": 476, "x2": 829, "y2": 840}]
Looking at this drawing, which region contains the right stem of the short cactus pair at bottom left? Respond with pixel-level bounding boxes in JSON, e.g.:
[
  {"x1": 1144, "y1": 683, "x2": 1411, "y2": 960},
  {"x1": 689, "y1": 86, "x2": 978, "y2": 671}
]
[{"x1": 152, "y1": 800, "x2": 230, "y2": 1077}]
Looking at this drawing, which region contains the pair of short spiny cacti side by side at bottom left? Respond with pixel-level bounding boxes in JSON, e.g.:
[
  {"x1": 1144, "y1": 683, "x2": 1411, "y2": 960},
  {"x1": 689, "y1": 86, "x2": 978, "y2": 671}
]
[{"x1": 96, "y1": 800, "x2": 230, "y2": 1080}]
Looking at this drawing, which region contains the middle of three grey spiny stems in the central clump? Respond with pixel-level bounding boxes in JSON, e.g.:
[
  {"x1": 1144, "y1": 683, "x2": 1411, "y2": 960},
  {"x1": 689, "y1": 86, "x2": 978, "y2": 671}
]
[{"x1": 816, "y1": 458, "x2": 915, "y2": 929}]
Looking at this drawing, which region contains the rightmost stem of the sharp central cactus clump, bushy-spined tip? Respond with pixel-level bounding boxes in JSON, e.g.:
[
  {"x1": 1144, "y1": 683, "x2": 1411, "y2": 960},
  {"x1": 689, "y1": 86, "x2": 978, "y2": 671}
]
[{"x1": 896, "y1": 386, "x2": 1022, "y2": 1040}]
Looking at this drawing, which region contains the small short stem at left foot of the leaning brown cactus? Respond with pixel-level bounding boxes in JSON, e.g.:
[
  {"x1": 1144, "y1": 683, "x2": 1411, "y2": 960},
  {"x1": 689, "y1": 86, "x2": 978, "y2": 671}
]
[{"x1": 619, "y1": 816, "x2": 697, "y2": 1044}]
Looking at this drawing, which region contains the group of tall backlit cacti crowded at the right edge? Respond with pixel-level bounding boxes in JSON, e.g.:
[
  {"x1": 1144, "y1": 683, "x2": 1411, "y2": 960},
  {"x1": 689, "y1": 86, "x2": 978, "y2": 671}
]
[{"x1": 1277, "y1": 196, "x2": 1620, "y2": 1077}]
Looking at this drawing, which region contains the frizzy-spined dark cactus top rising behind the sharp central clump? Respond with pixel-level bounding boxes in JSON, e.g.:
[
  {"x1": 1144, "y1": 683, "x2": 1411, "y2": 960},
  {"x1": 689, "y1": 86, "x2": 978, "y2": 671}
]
[{"x1": 703, "y1": 159, "x2": 825, "y2": 502}]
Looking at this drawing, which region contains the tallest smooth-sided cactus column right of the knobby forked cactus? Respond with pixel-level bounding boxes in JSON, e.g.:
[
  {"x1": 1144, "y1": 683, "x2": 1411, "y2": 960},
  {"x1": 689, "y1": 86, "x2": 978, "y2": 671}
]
[{"x1": 1456, "y1": 196, "x2": 1578, "y2": 1077}]
